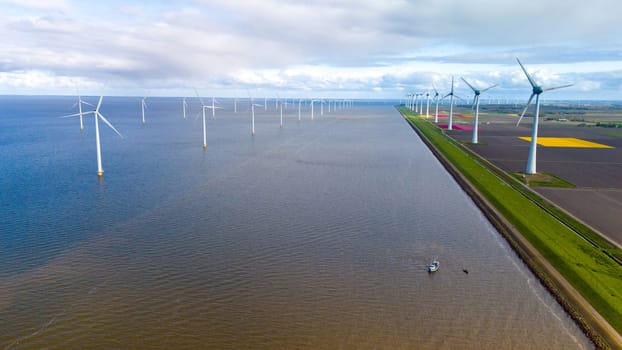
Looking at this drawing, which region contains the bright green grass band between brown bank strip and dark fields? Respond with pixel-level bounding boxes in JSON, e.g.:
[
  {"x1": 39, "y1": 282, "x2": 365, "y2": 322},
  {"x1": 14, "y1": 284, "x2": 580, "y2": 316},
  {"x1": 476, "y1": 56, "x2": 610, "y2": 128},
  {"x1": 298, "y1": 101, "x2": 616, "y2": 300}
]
[{"x1": 400, "y1": 109, "x2": 622, "y2": 347}]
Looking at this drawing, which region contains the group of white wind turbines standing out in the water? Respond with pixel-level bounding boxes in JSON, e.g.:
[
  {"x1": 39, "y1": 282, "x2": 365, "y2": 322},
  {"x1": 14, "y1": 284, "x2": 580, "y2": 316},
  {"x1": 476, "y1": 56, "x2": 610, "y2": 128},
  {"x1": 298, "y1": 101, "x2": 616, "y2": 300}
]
[{"x1": 61, "y1": 89, "x2": 354, "y2": 178}]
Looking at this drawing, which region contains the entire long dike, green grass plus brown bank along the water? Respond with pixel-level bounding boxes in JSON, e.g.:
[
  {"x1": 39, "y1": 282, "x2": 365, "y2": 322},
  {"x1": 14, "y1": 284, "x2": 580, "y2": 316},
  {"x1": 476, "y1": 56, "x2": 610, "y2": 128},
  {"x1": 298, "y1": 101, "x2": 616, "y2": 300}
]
[{"x1": 399, "y1": 108, "x2": 622, "y2": 348}]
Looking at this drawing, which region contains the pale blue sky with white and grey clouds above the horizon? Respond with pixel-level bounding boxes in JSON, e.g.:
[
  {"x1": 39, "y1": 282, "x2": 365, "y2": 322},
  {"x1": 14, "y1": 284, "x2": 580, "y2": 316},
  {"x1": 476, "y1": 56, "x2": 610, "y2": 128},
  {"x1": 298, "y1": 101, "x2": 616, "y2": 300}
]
[{"x1": 0, "y1": 0, "x2": 622, "y2": 100}]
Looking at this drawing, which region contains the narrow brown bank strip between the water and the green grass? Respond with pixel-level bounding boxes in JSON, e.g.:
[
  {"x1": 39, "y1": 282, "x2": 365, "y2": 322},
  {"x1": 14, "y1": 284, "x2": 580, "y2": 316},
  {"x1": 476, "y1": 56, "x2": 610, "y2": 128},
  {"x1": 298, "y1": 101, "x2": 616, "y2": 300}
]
[{"x1": 398, "y1": 109, "x2": 622, "y2": 349}]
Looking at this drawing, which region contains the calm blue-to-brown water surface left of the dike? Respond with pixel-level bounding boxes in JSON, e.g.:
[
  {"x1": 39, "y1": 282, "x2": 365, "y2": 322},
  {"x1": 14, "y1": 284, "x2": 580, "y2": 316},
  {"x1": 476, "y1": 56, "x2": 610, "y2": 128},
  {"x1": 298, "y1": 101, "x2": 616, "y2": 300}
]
[{"x1": 0, "y1": 97, "x2": 592, "y2": 349}]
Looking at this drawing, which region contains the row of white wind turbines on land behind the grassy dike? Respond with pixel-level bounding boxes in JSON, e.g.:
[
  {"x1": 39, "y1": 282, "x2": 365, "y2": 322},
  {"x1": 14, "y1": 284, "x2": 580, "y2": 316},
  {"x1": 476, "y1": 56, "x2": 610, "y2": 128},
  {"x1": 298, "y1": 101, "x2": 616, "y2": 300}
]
[{"x1": 407, "y1": 58, "x2": 572, "y2": 175}]
